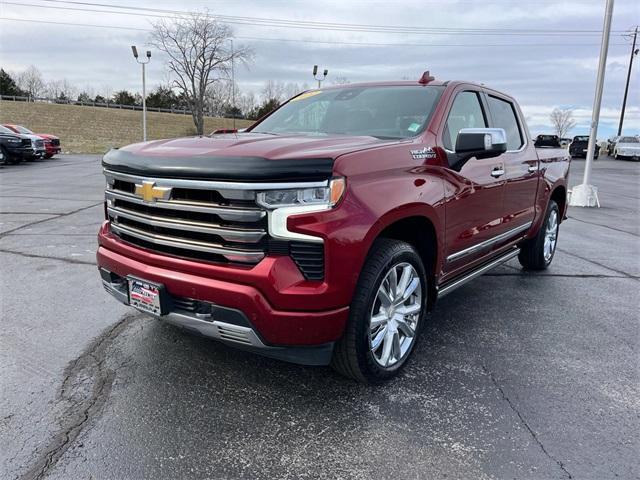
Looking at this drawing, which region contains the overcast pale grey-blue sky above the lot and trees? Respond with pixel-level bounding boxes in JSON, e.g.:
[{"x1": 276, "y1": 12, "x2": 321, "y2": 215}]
[{"x1": 0, "y1": 0, "x2": 640, "y2": 138}]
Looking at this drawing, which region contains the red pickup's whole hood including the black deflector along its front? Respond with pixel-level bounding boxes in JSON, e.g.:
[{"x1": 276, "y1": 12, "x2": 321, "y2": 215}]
[{"x1": 103, "y1": 132, "x2": 397, "y2": 181}]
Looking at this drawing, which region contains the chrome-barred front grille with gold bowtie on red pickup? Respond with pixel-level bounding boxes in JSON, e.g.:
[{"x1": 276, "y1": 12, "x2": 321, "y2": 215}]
[{"x1": 104, "y1": 170, "x2": 268, "y2": 264}]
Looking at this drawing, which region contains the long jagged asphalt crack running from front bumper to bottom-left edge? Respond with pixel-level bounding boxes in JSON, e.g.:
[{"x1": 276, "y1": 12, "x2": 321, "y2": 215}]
[{"x1": 18, "y1": 313, "x2": 137, "y2": 480}]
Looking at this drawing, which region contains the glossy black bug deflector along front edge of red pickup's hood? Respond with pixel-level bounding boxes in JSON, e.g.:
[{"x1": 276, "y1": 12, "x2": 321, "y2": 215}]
[{"x1": 102, "y1": 149, "x2": 333, "y2": 182}]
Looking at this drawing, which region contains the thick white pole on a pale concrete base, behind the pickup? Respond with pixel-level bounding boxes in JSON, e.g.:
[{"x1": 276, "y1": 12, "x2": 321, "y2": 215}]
[{"x1": 569, "y1": 0, "x2": 613, "y2": 207}]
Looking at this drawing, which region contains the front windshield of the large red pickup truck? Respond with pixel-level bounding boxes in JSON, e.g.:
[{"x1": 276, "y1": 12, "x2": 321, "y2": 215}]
[{"x1": 250, "y1": 85, "x2": 444, "y2": 138}]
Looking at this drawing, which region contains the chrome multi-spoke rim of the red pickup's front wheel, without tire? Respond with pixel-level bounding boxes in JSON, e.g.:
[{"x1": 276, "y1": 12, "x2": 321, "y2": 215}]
[{"x1": 369, "y1": 262, "x2": 422, "y2": 368}]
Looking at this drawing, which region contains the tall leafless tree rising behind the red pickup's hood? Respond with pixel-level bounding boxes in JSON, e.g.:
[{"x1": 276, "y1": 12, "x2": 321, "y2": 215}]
[{"x1": 151, "y1": 12, "x2": 251, "y2": 135}]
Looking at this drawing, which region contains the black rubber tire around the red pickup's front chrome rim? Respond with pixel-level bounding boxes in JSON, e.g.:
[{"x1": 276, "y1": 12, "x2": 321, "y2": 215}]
[{"x1": 331, "y1": 238, "x2": 429, "y2": 384}]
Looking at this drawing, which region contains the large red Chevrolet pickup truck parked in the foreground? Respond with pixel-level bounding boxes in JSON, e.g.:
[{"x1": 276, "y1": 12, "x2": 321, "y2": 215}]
[{"x1": 97, "y1": 74, "x2": 570, "y2": 383}]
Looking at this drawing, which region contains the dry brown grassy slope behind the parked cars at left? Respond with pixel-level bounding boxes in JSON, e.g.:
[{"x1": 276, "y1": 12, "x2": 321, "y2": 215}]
[{"x1": 0, "y1": 100, "x2": 251, "y2": 153}]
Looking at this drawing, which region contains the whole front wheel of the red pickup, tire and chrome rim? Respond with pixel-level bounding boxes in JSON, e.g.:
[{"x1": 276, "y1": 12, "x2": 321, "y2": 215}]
[{"x1": 331, "y1": 238, "x2": 428, "y2": 383}]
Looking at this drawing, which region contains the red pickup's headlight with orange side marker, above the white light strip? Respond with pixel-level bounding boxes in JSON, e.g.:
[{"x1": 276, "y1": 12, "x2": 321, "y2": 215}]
[{"x1": 256, "y1": 177, "x2": 345, "y2": 210}]
